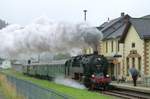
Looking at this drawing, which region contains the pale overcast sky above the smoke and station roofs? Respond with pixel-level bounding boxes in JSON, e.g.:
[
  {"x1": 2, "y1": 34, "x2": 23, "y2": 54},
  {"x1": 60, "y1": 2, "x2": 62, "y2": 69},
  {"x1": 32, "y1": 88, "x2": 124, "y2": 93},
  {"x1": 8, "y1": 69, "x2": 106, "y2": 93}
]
[{"x1": 0, "y1": 0, "x2": 150, "y2": 26}]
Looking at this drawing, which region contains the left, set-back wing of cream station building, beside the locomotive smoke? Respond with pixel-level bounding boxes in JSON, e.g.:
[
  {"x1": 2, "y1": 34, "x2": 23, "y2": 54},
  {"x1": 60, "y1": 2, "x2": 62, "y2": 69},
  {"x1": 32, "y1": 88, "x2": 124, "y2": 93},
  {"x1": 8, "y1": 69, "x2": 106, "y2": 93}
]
[{"x1": 97, "y1": 13, "x2": 130, "y2": 79}]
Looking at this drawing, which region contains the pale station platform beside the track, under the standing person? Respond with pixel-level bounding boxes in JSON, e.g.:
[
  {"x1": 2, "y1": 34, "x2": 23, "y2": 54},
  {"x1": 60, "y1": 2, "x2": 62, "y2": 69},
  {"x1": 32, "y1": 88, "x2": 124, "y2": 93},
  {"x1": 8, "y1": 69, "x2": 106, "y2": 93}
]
[{"x1": 111, "y1": 81, "x2": 150, "y2": 94}]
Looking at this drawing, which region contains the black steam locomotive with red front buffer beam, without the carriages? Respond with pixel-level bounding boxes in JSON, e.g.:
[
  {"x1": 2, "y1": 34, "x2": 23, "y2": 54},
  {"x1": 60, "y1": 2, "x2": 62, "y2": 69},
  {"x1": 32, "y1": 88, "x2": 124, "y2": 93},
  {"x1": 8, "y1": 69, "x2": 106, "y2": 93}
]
[{"x1": 65, "y1": 52, "x2": 111, "y2": 89}]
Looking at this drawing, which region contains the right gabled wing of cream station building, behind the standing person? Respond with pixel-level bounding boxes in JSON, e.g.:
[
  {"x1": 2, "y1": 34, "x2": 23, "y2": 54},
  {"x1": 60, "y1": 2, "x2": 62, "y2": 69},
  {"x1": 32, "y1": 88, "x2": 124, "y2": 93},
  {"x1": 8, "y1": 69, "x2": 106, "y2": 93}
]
[{"x1": 120, "y1": 16, "x2": 150, "y2": 77}]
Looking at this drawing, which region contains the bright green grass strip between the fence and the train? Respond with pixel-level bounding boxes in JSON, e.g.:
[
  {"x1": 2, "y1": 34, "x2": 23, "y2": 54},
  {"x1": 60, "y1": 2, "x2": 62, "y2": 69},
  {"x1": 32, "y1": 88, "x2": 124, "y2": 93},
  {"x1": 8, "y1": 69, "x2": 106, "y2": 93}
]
[{"x1": 2, "y1": 70, "x2": 113, "y2": 99}]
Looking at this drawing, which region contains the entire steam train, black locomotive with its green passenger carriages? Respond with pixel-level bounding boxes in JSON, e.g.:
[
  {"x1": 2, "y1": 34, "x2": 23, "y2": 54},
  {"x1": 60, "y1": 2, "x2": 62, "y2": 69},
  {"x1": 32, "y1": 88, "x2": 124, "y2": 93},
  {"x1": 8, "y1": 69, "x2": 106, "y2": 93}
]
[{"x1": 23, "y1": 52, "x2": 111, "y2": 89}]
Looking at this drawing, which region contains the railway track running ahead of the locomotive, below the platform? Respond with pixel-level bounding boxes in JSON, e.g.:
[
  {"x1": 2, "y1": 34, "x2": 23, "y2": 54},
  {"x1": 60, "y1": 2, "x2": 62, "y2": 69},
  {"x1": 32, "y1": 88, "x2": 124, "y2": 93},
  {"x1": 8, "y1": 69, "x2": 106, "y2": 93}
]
[{"x1": 102, "y1": 89, "x2": 150, "y2": 99}]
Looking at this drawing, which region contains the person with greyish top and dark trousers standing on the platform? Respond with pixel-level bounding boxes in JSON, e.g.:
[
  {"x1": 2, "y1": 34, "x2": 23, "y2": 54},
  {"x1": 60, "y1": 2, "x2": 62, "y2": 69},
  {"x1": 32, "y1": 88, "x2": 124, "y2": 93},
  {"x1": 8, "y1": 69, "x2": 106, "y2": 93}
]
[{"x1": 129, "y1": 66, "x2": 138, "y2": 86}]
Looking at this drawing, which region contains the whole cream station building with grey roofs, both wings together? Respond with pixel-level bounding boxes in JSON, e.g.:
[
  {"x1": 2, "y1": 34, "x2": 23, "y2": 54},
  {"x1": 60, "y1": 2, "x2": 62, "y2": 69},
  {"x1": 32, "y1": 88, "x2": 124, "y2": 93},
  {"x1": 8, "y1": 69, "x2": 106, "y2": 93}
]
[{"x1": 86, "y1": 13, "x2": 150, "y2": 80}]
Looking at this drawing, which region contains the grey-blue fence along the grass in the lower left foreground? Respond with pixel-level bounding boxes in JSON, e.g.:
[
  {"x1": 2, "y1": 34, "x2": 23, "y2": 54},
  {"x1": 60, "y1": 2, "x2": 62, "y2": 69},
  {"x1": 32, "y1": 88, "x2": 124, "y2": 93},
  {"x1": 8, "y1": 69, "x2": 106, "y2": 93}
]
[{"x1": 7, "y1": 76, "x2": 72, "y2": 99}]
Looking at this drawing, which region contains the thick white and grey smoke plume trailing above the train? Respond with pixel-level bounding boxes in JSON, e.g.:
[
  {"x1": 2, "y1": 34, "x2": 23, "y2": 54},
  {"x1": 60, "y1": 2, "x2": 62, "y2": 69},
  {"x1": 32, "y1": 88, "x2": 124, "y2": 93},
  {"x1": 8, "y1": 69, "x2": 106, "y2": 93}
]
[{"x1": 0, "y1": 16, "x2": 102, "y2": 57}]
